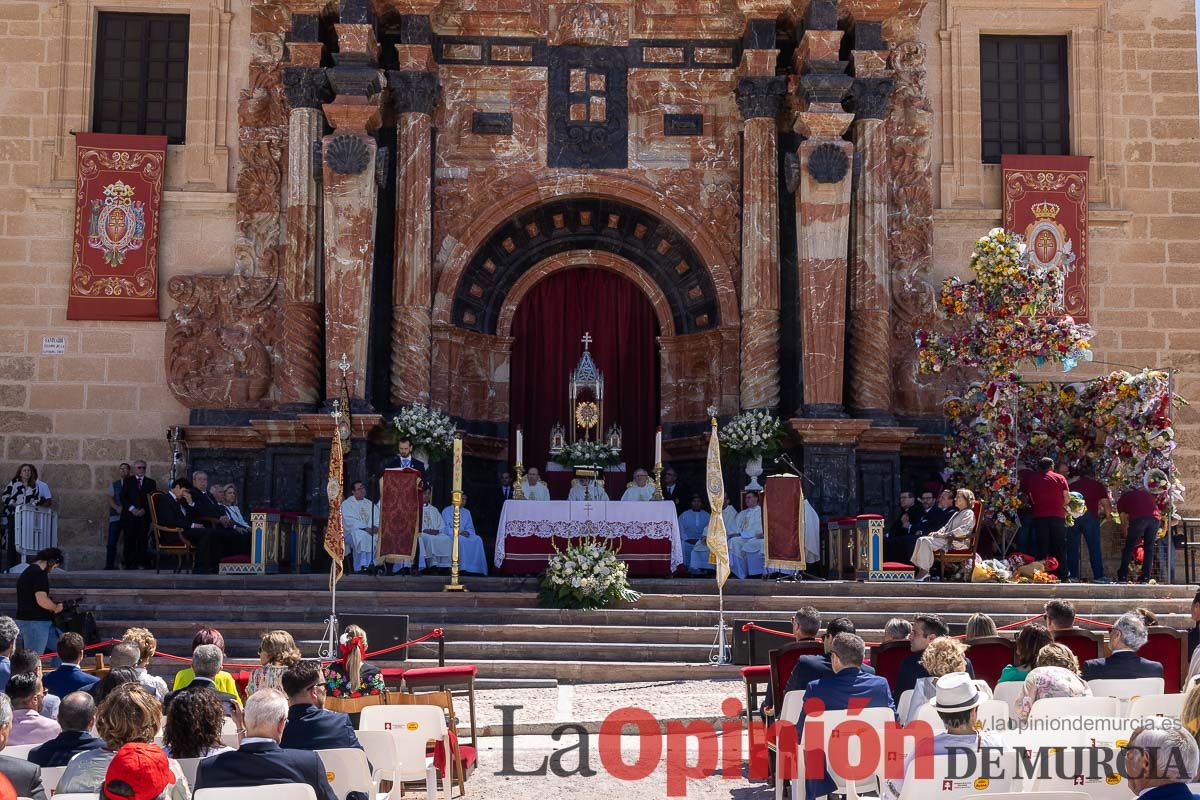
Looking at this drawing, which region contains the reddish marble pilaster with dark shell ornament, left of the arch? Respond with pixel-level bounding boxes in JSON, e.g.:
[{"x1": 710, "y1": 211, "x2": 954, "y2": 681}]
[{"x1": 322, "y1": 17, "x2": 383, "y2": 401}]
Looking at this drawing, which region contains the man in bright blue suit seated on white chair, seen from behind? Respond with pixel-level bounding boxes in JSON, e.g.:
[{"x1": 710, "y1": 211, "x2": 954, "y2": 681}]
[{"x1": 796, "y1": 633, "x2": 895, "y2": 800}]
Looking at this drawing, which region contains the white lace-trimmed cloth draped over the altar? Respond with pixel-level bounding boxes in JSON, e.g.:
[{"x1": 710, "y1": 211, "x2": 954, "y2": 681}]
[{"x1": 496, "y1": 500, "x2": 683, "y2": 572}]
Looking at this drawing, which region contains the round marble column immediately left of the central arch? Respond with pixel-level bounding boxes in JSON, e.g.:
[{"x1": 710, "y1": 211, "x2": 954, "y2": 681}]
[{"x1": 388, "y1": 37, "x2": 438, "y2": 405}]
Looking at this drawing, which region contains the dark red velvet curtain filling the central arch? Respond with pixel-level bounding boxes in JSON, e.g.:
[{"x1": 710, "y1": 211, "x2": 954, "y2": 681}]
[{"x1": 509, "y1": 269, "x2": 659, "y2": 479}]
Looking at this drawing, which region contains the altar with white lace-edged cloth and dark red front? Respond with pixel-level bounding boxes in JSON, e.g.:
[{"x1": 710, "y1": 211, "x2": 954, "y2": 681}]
[{"x1": 496, "y1": 500, "x2": 683, "y2": 577}]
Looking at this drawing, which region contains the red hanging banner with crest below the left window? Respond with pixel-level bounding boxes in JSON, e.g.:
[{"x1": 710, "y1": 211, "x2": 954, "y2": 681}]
[{"x1": 67, "y1": 133, "x2": 167, "y2": 320}]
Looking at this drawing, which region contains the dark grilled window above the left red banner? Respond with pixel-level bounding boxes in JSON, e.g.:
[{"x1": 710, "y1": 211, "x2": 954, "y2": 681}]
[{"x1": 91, "y1": 12, "x2": 187, "y2": 144}]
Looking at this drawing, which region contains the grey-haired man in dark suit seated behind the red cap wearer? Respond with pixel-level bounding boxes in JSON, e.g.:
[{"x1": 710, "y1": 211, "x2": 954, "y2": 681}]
[{"x1": 194, "y1": 688, "x2": 338, "y2": 800}]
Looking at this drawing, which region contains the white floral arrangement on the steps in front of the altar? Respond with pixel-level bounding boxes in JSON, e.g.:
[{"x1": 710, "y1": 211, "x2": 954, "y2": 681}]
[{"x1": 538, "y1": 536, "x2": 641, "y2": 608}]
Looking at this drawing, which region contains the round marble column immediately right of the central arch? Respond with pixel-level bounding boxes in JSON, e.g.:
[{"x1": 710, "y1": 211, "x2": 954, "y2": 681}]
[{"x1": 737, "y1": 49, "x2": 787, "y2": 409}]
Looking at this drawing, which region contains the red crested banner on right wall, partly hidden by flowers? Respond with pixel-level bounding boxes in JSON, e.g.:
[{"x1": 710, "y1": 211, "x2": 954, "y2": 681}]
[{"x1": 1000, "y1": 156, "x2": 1088, "y2": 323}]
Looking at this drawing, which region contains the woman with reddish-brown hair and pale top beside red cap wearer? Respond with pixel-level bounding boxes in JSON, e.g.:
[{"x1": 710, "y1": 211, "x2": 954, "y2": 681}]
[{"x1": 58, "y1": 682, "x2": 191, "y2": 800}]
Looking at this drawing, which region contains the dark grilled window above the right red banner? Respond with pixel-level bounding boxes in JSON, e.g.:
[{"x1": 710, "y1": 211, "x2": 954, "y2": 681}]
[{"x1": 979, "y1": 36, "x2": 1070, "y2": 164}]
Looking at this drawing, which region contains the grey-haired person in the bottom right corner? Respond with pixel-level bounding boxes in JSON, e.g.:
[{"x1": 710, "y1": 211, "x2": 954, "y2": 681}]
[{"x1": 1124, "y1": 723, "x2": 1200, "y2": 800}]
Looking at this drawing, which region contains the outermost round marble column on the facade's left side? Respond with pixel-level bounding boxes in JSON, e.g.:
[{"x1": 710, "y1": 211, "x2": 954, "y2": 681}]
[{"x1": 280, "y1": 51, "x2": 330, "y2": 405}]
